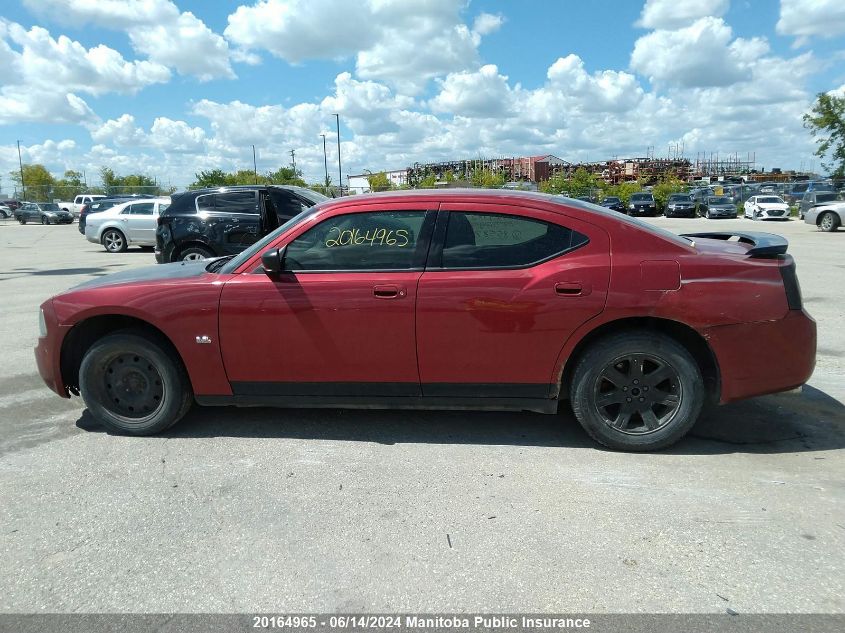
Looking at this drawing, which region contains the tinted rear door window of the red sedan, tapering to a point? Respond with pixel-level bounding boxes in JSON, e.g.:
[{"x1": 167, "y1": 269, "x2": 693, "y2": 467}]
[{"x1": 442, "y1": 211, "x2": 587, "y2": 268}]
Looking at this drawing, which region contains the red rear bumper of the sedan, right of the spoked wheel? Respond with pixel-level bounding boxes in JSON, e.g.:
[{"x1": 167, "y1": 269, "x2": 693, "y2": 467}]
[{"x1": 704, "y1": 309, "x2": 816, "y2": 403}]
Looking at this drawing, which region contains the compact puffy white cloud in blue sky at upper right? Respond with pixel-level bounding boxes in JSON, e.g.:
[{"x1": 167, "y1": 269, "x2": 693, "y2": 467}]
[{"x1": 631, "y1": 17, "x2": 756, "y2": 87}]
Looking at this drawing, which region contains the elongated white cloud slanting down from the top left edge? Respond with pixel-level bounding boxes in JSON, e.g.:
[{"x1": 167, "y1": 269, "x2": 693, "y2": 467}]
[{"x1": 24, "y1": 0, "x2": 235, "y2": 81}]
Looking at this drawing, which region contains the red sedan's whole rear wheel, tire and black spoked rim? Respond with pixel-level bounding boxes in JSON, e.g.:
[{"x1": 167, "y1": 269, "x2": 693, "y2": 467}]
[{"x1": 570, "y1": 331, "x2": 706, "y2": 451}]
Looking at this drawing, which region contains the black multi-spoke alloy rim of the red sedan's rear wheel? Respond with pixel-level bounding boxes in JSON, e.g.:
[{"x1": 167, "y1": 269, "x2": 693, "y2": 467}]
[{"x1": 593, "y1": 354, "x2": 683, "y2": 435}]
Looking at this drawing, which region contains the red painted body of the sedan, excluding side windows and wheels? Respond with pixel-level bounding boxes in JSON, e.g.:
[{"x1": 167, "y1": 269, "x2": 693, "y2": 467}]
[{"x1": 36, "y1": 190, "x2": 816, "y2": 410}]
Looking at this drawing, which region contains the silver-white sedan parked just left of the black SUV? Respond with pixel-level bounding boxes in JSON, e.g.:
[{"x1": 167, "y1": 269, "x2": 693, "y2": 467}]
[{"x1": 85, "y1": 198, "x2": 170, "y2": 253}]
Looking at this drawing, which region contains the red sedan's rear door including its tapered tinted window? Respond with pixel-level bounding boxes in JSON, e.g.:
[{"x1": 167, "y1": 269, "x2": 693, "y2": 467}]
[{"x1": 417, "y1": 203, "x2": 610, "y2": 398}]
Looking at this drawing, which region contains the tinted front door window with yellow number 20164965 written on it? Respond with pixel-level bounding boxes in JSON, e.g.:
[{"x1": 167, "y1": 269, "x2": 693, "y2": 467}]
[{"x1": 285, "y1": 211, "x2": 426, "y2": 270}]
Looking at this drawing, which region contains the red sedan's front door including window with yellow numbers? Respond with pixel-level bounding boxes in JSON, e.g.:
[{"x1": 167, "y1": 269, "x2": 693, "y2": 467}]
[{"x1": 220, "y1": 205, "x2": 435, "y2": 401}]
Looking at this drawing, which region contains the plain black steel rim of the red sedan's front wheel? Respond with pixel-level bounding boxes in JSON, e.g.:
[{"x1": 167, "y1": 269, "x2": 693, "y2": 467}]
[{"x1": 102, "y1": 353, "x2": 164, "y2": 423}]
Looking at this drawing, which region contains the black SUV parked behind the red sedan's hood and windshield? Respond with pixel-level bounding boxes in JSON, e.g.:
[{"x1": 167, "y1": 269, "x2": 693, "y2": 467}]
[{"x1": 155, "y1": 185, "x2": 328, "y2": 264}]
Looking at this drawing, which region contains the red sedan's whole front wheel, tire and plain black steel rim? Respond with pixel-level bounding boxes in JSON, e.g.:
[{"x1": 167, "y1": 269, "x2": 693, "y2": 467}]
[{"x1": 79, "y1": 330, "x2": 193, "y2": 435}]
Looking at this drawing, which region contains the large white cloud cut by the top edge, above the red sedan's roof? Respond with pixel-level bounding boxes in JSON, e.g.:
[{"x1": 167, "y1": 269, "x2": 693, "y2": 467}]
[{"x1": 225, "y1": 0, "x2": 503, "y2": 94}]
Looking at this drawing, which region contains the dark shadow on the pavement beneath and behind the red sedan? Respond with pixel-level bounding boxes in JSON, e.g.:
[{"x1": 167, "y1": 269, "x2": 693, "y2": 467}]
[{"x1": 77, "y1": 386, "x2": 845, "y2": 455}]
